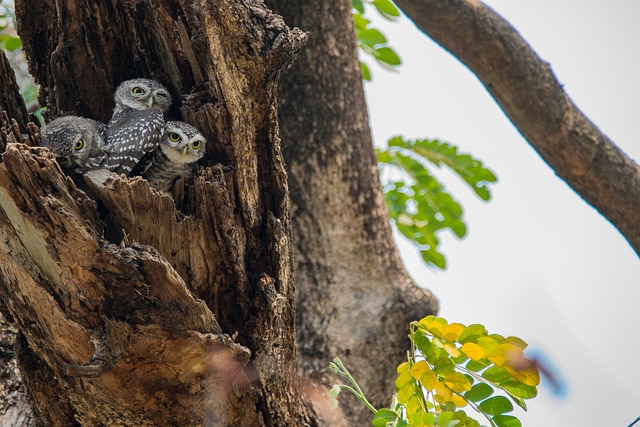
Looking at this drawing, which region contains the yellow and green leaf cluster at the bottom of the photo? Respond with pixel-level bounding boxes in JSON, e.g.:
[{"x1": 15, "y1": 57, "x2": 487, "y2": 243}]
[{"x1": 330, "y1": 316, "x2": 540, "y2": 427}]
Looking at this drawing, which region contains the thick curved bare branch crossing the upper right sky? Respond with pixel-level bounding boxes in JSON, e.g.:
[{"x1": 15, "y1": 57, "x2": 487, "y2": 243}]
[{"x1": 396, "y1": 0, "x2": 640, "y2": 254}]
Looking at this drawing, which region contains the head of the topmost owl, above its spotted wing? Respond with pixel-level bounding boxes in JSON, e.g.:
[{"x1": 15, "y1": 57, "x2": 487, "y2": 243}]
[{"x1": 114, "y1": 79, "x2": 171, "y2": 112}]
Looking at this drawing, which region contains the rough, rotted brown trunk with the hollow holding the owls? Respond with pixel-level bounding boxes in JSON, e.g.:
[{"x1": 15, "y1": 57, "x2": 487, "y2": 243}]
[{"x1": 0, "y1": 0, "x2": 317, "y2": 426}]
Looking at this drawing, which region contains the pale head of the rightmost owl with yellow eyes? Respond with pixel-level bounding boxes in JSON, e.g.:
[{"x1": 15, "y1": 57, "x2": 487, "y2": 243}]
[{"x1": 160, "y1": 121, "x2": 207, "y2": 163}]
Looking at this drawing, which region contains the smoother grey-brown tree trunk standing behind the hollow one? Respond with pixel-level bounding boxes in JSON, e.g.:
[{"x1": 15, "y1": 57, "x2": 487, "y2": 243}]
[{"x1": 268, "y1": 0, "x2": 437, "y2": 425}]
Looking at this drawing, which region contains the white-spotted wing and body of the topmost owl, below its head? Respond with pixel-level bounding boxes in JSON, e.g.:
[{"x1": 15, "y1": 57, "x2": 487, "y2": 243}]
[{"x1": 106, "y1": 108, "x2": 164, "y2": 176}]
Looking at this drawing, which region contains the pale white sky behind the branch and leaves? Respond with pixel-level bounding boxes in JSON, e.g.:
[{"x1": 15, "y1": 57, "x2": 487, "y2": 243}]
[{"x1": 367, "y1": 0, "x2": 640, "y2": 427}]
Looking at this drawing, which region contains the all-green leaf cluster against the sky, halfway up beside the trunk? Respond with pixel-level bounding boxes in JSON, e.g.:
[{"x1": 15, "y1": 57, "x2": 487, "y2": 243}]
[{"x1": 377, "y1": 137, "x2": 497, "y2": 269}]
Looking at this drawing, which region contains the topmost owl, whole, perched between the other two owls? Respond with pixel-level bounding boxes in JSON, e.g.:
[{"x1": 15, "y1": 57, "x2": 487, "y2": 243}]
[{"x1": 105, "y1": 79, "x2": 171, "y2": 176}]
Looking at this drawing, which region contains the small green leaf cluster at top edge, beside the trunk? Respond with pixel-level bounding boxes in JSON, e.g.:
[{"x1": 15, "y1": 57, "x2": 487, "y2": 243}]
[{"x1": 352, "y1": 0, "x2": 402, "y2": 81}]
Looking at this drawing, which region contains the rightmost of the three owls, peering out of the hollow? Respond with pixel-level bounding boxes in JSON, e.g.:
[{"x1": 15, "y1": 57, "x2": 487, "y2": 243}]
[{"x1": 137, "y1": 121, "x2": 206, "y2": 194}]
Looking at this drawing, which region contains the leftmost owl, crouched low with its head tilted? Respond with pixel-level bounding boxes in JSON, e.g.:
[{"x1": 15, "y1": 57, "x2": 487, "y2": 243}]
[{"x1": 42, "y1": 116, "x2": 109, "y2": 174}]
